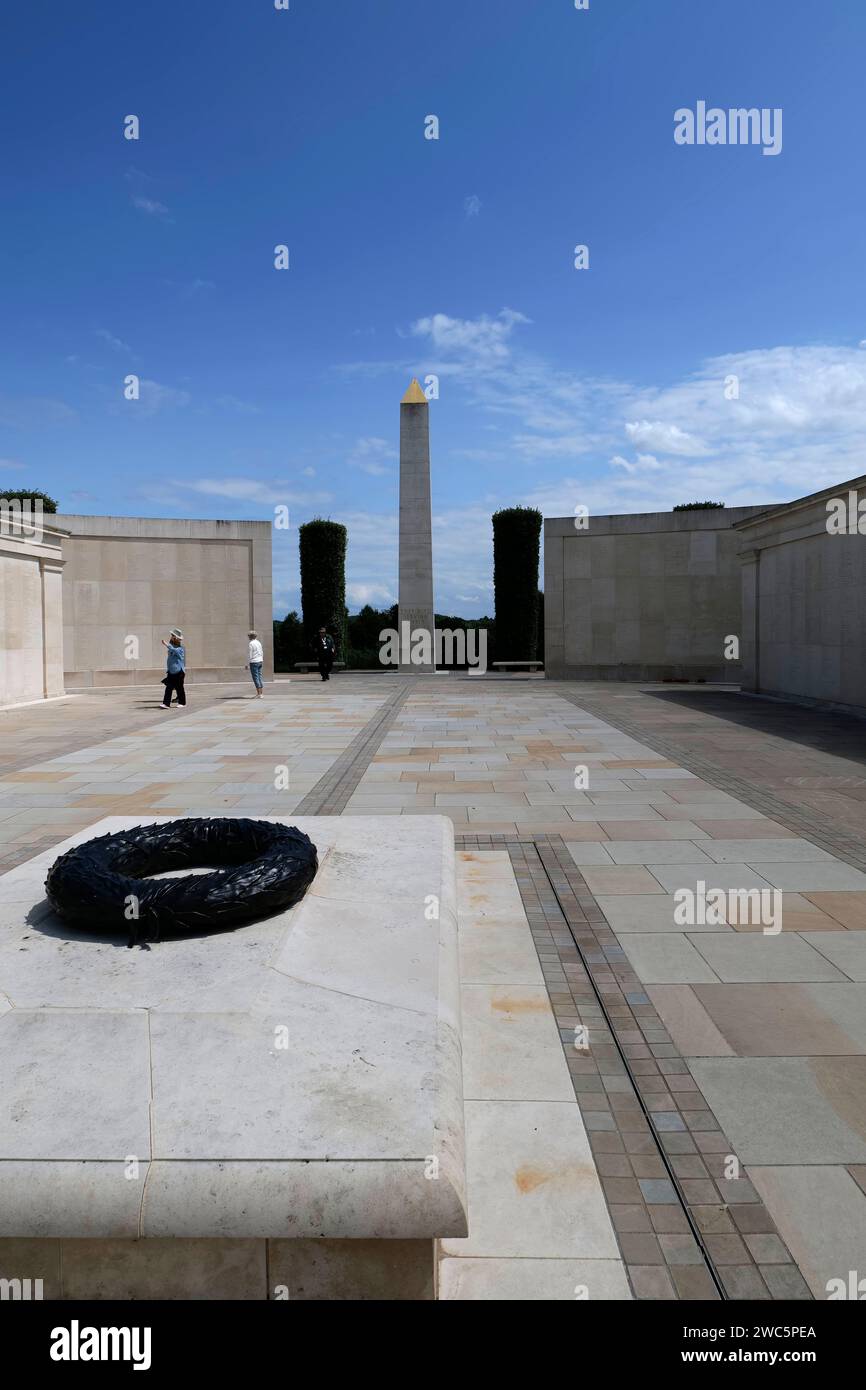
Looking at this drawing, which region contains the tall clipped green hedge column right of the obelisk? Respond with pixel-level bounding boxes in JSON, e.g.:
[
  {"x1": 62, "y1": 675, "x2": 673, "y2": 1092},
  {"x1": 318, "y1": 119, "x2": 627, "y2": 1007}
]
[{"x1": 493, "y1": 507, "x2": 541, "y2": 662}]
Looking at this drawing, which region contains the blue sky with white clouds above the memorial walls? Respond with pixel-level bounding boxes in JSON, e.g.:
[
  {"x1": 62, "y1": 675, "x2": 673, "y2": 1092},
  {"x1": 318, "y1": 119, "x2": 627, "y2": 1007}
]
[{"x1": 0, "y1": 0, "x2": 866, "y2": 617}]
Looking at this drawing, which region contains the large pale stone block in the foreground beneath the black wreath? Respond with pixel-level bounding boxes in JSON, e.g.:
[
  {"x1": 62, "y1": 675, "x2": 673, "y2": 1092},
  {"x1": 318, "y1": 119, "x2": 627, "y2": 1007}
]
[{"x1": 0, "y1": 808, "x2": 467, "y2": 1298}]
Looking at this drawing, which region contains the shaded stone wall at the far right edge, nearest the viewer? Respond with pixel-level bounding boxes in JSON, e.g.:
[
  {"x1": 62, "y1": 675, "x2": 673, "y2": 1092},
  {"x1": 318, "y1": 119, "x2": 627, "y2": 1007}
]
[{"x1": 737, "y1": 477, "x2": 866, "y2": 710}]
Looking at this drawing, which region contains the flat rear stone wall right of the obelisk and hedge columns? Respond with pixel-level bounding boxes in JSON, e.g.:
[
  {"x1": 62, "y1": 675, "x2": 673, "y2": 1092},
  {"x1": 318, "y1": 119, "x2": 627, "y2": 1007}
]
[{"x1": 545, "y1": 507, "x2": 766, "y2": 681}]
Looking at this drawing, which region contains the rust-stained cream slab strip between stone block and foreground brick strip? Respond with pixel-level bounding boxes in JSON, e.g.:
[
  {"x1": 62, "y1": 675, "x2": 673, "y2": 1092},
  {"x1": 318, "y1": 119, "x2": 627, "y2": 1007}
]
[{"x1": 439, "y1": 851, "x2": 630, "y2": 1300}]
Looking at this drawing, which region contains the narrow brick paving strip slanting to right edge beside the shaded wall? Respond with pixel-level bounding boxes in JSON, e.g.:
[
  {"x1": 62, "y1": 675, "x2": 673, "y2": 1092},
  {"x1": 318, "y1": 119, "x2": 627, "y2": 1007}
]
[{"x1": 555, "y1": 687, "x2": 866, "y2": 873}]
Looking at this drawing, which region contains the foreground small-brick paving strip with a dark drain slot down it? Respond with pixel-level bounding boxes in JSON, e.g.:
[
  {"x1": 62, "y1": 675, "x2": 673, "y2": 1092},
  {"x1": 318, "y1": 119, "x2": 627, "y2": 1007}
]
[{"x1": 456, "y1": 834, "x2": 812, "y2": 1301}]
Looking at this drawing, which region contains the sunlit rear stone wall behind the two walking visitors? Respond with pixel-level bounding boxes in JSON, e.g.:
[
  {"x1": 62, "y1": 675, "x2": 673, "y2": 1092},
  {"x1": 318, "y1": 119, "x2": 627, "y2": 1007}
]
[{"x1": 57, "y1": 516, "x2": 274, "y2": 688}]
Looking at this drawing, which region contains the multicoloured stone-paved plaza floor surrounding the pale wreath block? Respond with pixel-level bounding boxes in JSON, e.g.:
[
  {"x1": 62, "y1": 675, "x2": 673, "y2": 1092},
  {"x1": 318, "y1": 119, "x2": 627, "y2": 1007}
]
[{"x1": 0, "y1": 674, "x2": 866, "y2": 1300}]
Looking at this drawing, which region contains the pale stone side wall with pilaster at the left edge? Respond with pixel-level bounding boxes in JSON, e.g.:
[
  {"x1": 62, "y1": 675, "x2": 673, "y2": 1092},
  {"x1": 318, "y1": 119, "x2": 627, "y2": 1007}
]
[{"x1": 0, "y1": 527, "x2": 64, "y2": 706}]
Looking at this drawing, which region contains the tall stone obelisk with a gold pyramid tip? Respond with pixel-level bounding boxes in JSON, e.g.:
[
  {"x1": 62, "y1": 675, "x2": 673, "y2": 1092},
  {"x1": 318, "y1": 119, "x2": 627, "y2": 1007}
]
[{"x1": 398, "y1": 378, "x2": 435, "y2": 671}]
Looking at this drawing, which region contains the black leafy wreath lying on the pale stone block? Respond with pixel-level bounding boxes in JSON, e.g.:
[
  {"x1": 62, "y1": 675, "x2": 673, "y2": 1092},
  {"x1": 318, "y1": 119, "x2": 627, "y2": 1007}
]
[{"x1": 44, "y1": 817, "x2": 318, "y2": 947}]
